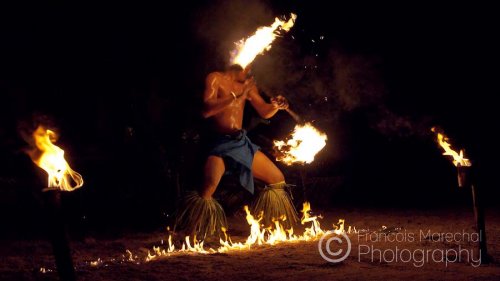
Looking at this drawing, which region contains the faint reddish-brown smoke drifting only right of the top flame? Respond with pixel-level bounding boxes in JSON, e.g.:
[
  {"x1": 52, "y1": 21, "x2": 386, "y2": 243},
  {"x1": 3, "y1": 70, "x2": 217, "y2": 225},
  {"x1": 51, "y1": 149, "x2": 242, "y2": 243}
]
[{"x1": 254, "y1": 41, "x2": 430, "y2": 136}]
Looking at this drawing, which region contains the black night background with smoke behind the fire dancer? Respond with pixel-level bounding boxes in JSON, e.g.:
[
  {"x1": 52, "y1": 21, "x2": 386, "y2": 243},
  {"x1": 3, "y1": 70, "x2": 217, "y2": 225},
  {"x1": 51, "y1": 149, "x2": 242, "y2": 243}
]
[{"x1": 0, "y1": 1, "x2": 500, "y2": 237}]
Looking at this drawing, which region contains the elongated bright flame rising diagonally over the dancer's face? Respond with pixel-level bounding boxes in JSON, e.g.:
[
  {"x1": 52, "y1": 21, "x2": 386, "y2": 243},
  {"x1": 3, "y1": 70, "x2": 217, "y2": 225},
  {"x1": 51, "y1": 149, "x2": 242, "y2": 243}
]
[{"x1": 231, "y1": 13, "x2": 297, "y2": 68}]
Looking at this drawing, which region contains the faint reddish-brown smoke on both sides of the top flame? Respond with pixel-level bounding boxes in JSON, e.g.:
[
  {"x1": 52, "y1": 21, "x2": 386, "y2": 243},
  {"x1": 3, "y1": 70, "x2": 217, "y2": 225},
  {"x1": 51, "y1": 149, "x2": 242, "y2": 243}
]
[{"x1": 192, "y1": 0, "x2": 429, "y2": 136}]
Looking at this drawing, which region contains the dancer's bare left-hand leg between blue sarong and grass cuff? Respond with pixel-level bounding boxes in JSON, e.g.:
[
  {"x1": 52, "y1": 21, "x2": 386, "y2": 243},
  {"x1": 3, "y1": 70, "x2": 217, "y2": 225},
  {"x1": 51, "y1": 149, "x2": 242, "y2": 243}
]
[{"x1": 200, "y1": 155, "x2": 226, "y2": 199}]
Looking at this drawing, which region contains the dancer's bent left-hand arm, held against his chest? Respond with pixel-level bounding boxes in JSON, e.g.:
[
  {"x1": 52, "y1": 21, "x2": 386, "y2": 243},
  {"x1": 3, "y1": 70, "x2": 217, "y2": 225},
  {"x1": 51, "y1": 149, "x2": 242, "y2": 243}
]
[{"x1": 202, "y1": 73, "x2": 235, "y2": 118}]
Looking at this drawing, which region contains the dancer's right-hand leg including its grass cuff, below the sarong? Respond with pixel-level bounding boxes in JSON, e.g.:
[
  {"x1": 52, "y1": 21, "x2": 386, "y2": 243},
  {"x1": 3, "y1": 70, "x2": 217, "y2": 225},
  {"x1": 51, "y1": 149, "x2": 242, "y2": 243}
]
[{"x1": 252, "y1": 151, "x2": 298, "y2": 228}]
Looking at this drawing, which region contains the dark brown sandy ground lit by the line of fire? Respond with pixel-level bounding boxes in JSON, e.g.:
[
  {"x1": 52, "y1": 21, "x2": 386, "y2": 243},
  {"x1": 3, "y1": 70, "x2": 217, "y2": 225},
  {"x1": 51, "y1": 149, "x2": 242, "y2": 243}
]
[{"x1": 0, "y1": 206, "x2": 500, "y2": 280}]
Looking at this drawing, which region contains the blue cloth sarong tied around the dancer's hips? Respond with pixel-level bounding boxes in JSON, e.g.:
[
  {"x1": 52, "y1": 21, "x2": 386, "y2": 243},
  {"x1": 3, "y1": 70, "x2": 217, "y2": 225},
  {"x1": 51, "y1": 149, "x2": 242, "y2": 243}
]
[{"x1": 208, "y1": 130, "x2": 260, "y2": 194}]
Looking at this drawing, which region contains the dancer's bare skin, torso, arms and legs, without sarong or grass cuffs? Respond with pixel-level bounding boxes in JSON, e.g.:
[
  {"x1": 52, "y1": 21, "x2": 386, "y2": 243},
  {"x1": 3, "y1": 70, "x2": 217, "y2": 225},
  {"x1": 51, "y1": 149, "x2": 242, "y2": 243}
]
[{"x1": 201, "y1": 65, "x2": 288, "y2": 198}]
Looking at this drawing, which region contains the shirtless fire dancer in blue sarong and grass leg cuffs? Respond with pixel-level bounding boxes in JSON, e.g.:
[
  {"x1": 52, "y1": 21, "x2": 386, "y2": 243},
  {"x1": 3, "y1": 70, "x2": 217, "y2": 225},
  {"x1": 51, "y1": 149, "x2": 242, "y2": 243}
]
[{"x1": 176, "y1": 64, "x2": 298, "y2": 237}]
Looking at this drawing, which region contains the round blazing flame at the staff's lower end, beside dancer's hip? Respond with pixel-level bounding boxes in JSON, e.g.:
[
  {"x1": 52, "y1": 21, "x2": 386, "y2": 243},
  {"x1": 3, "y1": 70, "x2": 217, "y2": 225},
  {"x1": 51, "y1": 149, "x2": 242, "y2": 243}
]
[{"x1": 274, "y1": 123, "x2": 327, "y2": 165}]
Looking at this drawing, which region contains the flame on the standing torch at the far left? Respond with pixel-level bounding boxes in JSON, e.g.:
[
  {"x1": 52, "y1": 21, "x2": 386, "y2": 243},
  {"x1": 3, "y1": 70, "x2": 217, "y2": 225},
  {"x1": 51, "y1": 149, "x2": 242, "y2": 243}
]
[{"x1": 28, "y1": 126, "x2": 83, "y2": 191}]
